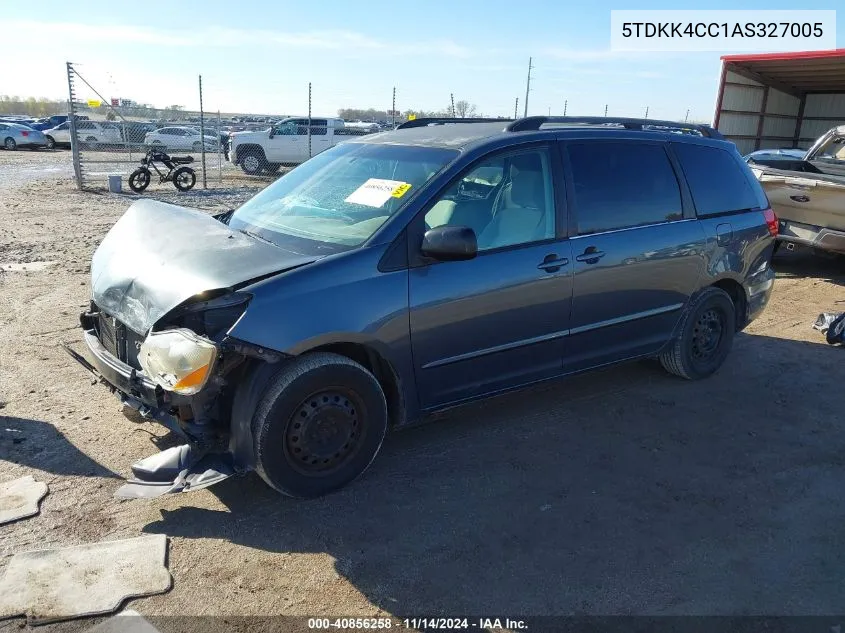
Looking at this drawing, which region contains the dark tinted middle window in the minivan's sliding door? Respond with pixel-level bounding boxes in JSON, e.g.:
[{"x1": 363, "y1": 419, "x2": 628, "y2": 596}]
[{"x1": 568, "y1": 142, "x2": 683, "y2": 235}]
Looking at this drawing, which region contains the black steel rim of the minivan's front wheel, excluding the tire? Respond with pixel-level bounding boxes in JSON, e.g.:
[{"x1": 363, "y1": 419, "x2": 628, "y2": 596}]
[{"x1": 285, "y1": 387, "x2": 361, "y2": 475}]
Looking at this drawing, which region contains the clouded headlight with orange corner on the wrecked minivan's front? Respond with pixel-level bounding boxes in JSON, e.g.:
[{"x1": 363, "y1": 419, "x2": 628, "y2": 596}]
[{"x1": 138, "y1": 328, "x2": 217, "y2": 396}]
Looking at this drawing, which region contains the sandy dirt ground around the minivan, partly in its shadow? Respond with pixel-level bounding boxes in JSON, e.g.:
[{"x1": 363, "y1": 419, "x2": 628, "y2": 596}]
[{"x1": 0, "y1": 152, "x2": 845, "y2": 630}]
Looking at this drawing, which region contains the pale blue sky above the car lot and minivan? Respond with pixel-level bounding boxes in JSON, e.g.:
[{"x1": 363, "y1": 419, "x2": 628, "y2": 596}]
[{"x1": 0, "y1": 0, "x2": 845, "y2": 120}]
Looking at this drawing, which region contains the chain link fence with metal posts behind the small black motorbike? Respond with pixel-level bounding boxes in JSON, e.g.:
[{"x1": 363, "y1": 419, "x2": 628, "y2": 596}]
[{"x1": 67, "y1": 63, "x2": 378, "y2": 200}]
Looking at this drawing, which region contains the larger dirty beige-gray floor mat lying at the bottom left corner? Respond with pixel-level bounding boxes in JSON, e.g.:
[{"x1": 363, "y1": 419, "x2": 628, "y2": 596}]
[{"x1": 0, "y1": 534, "x2": 171, "y2": 624}]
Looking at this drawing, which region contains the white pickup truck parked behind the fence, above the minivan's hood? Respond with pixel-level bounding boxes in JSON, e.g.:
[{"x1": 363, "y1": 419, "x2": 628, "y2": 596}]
[{"x1": 229, "y1": 117, "x2": 367, "y2": 174}]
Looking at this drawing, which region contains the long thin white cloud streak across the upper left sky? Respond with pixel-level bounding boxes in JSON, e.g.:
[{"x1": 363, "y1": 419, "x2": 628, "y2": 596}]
[{"x1": 4, "y1": 20, "x2": 472, "y2": 58}]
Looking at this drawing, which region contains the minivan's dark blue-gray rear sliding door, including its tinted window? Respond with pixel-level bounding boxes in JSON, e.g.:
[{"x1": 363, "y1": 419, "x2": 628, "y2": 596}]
[{"x1": 564, "y1": 140, "x2": 705, "y2": 371}]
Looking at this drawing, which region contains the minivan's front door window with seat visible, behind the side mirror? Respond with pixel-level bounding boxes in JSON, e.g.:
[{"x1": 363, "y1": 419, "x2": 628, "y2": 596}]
[{"x1": 425, "y1": 148, "x2": 555, "y2": 251}]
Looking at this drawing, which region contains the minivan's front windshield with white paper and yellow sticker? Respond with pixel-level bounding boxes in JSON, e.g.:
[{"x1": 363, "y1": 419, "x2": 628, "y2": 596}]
[{"x1": 229, "y1": 143, "x2": 458, "y2": 252}]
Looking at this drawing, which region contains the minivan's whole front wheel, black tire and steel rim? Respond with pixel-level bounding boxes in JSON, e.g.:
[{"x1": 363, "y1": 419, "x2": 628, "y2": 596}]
[{"x1": 252, "y1": 352, "x2": 388, "y2": 498}]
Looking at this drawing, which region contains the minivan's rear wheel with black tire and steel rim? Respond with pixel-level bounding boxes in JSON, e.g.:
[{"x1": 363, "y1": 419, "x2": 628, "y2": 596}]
[{"x1": 660, "y1": 286, "x2": 736, "y2": 380}]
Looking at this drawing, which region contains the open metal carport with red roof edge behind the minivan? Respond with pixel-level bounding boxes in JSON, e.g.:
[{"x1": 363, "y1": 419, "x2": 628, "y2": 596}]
[{"x1": 714, "y1": 48, "x2": 845, "y2": 154}]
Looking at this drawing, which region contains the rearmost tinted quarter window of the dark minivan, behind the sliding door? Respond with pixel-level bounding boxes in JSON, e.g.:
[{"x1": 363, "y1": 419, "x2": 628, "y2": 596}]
[{"x1": 672, "y1": 143, "x2": 766, "y2": 217}]
